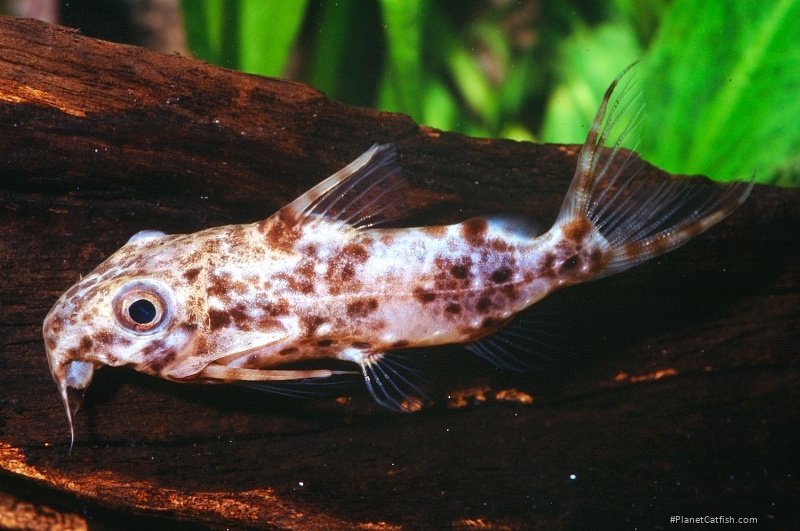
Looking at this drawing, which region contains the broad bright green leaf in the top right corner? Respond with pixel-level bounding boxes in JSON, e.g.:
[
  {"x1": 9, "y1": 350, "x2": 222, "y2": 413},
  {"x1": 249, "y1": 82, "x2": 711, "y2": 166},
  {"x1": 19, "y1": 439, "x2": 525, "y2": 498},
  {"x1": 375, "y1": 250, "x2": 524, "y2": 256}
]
[{"x1": 640, "y1": 0, "x2": 800, "y2": 185}]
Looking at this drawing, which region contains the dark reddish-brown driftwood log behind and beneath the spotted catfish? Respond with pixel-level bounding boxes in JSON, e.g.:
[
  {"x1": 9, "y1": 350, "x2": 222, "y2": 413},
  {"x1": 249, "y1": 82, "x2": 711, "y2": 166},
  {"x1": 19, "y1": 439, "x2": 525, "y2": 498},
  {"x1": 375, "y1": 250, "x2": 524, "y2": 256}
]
[{"x1": 0, "y1": 19, "x2": 800, "y2": 529}]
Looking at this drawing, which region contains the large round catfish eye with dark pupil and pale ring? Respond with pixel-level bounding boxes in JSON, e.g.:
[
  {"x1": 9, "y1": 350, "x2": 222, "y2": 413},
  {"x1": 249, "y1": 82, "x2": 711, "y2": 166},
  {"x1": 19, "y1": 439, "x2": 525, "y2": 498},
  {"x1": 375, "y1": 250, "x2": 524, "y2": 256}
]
[{"x1": 114, "y1": 282, "x2": 172, "y2": 334}]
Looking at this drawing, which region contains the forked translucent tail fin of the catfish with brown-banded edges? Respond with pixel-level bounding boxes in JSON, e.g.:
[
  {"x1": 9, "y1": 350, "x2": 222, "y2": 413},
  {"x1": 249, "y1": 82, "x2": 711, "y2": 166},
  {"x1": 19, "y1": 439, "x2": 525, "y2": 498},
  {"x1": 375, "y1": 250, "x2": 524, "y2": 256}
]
[{"x1": 556, "y1": 64, "x2": 753, "y2": 277}]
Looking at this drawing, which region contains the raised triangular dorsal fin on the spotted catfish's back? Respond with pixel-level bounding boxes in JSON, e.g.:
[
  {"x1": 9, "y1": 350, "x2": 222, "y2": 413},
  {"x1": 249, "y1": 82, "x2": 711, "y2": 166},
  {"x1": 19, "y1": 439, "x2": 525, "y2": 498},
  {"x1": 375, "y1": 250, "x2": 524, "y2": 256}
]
[{"x1": 282, "y1": 144, "x2": 408, "y2": 228}]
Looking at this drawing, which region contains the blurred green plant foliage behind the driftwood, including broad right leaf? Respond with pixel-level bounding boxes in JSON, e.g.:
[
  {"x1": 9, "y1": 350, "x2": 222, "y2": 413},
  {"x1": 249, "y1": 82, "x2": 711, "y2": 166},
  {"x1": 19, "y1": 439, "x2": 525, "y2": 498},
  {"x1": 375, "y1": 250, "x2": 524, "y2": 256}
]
[{"x1": 182, "y1": 0, "x2": 800, "y2": 186}]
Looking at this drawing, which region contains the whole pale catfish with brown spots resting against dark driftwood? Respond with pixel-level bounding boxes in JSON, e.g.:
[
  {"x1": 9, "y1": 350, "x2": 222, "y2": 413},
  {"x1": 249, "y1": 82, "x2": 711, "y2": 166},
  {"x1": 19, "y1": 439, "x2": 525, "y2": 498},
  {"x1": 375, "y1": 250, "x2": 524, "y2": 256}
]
[{"x1": 44, "y1": 65, "x2": 751, "y2": 448}]
